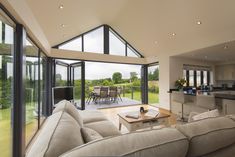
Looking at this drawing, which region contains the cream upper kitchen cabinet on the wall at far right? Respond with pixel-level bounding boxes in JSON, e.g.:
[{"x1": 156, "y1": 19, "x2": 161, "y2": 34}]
[{"x1": 215, "y1": 64, "x2": 235, "y2": 80}]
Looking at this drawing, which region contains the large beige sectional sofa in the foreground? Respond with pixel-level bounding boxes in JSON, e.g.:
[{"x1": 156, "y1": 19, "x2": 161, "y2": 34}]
[{"x1": 26, "y1": 101, "x2": 235, "y2": 157}]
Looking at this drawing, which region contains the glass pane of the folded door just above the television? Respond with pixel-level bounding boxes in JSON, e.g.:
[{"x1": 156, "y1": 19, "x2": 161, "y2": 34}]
[{"x1": 55, "y1": 64, "x2": 68, "y2": 86}]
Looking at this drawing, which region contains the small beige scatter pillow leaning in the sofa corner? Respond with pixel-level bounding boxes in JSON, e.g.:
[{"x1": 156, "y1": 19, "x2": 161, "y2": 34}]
[{"x1": 81, "y1": 127, "x2": 103, "y2": 143}]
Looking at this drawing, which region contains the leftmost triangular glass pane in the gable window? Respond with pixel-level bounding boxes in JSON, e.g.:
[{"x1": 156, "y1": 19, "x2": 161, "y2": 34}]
[{"x1": 59, "y1": 37, "x2": 82, "y2": 51}]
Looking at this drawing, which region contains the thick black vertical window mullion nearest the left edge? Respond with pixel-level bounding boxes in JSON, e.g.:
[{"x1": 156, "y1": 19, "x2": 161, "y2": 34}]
[{"x1": 12, "y1": 24, "x2": 26, "y2": 157}]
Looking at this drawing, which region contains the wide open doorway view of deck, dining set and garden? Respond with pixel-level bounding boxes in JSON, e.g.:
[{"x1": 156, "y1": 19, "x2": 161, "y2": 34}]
[{"x1": 85, "y1": 62, "x2": 141, "y2": 110}]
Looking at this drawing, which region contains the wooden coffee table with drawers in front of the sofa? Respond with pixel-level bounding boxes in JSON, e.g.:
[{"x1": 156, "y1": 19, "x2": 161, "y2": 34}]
[{"x1": 118, "y1": 109, "x2": 170, "y2": 132}]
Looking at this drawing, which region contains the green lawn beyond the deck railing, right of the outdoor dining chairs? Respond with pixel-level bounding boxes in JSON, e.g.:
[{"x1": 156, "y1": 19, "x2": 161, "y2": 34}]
[{"x1": 124, "y1": 91, "x2": 159, "y2": 104}]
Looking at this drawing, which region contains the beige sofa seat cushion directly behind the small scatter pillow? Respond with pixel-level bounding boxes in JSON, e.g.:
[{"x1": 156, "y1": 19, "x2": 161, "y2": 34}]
[{"x1": 84, "y1": 120, "x2": 121, "y2": 137}]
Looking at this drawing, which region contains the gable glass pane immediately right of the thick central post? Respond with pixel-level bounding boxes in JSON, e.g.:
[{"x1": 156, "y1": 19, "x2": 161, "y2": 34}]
[{"x1": 109, "y1": 31, "x2": 126, "y2": 56}]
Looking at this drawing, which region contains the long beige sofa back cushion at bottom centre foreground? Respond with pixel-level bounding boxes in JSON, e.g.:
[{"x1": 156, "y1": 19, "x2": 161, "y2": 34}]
[{"x1": 62, "y1": 128, "x2": 188, "y2": 157}]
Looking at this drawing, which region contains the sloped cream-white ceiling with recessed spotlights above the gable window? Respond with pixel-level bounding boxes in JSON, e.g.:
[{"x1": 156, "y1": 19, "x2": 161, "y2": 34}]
[{"x1": 26, "y1": 0, "x2": 235, "y2": 58}]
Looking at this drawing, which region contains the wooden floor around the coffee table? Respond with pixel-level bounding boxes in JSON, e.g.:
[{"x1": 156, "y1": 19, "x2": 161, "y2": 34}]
[{"x1": 99, "y1": 105, "x2": 176, "y2": 133}]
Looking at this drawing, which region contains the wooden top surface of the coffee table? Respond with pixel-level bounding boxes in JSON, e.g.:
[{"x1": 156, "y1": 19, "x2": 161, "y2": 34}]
[{"x1": 118, "y1": 109, "x2": 170, "y2": 123}]
